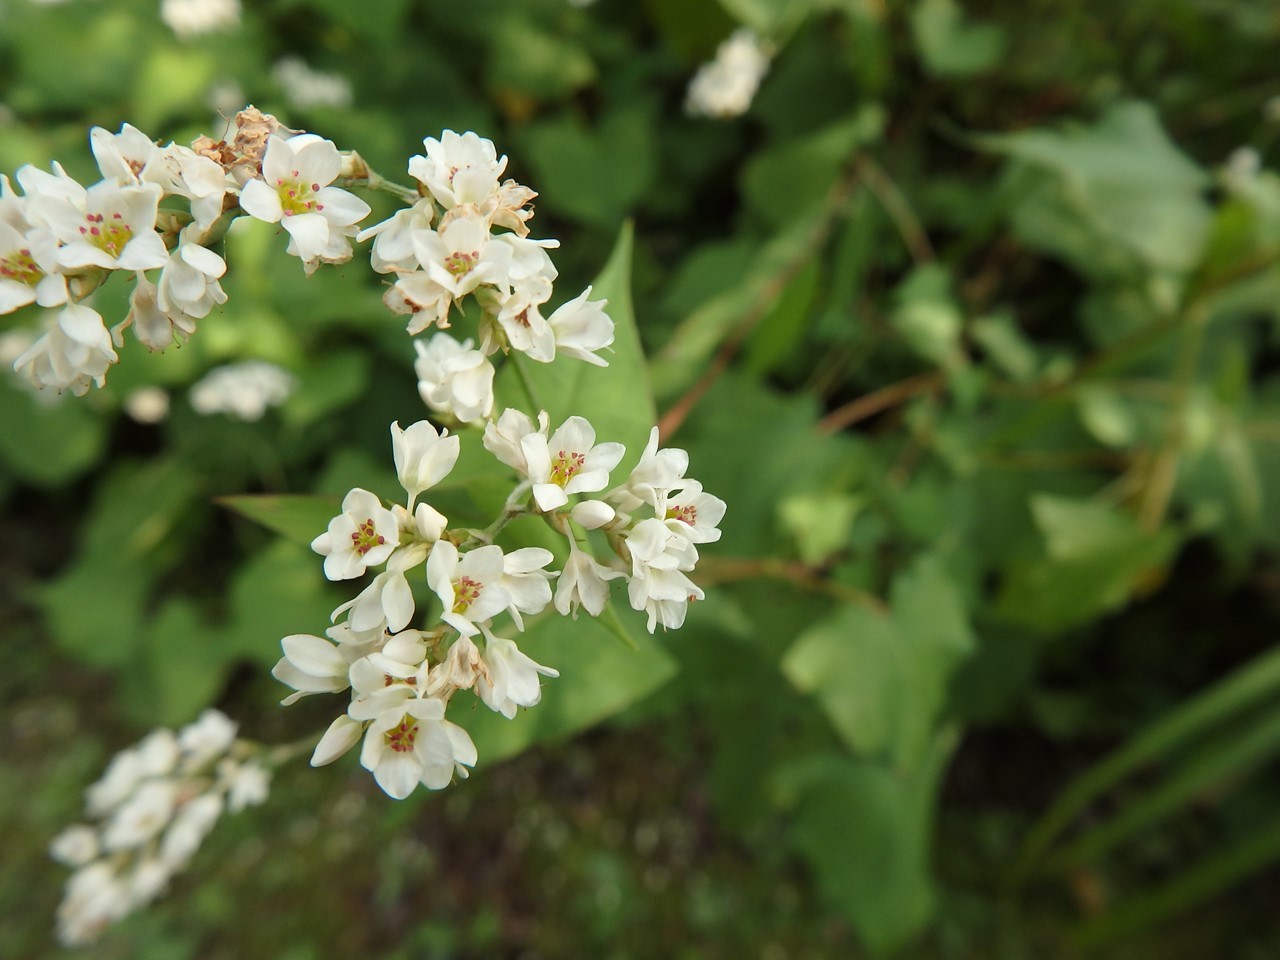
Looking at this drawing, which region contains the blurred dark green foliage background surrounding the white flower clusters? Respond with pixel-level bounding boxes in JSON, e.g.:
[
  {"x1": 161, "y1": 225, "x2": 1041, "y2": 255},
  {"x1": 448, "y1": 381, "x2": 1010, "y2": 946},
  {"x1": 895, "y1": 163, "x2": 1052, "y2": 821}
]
[{"x1": 0, "y1": 0, "x2": 1280, "y2": 960}]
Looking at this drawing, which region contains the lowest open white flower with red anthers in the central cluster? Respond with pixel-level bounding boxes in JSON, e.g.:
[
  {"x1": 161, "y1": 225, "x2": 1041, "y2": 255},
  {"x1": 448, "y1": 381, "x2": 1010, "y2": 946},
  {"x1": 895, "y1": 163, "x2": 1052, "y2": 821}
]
[{"x1": 360, "y1": 699, "x2": 476, "y2": 800}]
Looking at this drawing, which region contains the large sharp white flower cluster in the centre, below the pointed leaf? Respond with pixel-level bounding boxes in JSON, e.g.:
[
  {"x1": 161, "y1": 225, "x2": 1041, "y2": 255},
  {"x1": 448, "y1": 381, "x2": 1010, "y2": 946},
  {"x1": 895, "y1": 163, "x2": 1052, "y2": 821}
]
[{"x1": 273, "y1": 410, "x2": 724, "y2": 799}]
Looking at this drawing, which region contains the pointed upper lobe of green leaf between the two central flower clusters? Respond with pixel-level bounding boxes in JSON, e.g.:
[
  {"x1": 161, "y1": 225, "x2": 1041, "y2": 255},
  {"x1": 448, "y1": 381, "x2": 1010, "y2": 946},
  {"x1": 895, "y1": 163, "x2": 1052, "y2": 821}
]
[{"x1": 494, "y1": 224, "x2": 657, "y2": 463}]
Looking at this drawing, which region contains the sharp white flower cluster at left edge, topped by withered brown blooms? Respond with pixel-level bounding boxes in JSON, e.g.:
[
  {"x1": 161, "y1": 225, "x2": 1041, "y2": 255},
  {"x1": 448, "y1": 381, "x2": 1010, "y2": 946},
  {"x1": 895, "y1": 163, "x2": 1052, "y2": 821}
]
[{"x1": 0, "y1": 109, "x2": 369, "y2": 394}]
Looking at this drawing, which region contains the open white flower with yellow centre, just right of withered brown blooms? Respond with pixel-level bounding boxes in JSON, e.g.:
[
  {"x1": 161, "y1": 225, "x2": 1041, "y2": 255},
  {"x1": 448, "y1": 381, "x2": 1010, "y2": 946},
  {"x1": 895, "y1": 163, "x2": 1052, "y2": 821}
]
[{"x1": 241, "y1": 133, "x2": 369, "y2": 273}]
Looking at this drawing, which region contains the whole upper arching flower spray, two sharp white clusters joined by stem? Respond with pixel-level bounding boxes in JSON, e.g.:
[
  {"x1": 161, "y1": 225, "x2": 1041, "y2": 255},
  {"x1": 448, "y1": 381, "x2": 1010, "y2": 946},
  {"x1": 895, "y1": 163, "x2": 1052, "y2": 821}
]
[{"x1": 0, "y1": 108, "x2": 613, "y2": 422}]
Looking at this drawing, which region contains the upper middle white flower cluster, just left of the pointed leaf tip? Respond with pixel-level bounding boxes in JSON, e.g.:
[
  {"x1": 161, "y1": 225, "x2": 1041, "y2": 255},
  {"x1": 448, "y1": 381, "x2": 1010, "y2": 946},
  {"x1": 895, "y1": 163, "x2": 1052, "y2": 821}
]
[{"x1": 358, "y1": 131, "x2": 613, "y2": 422}]
